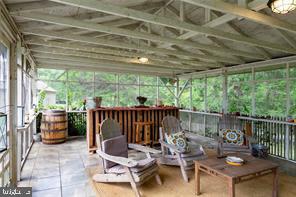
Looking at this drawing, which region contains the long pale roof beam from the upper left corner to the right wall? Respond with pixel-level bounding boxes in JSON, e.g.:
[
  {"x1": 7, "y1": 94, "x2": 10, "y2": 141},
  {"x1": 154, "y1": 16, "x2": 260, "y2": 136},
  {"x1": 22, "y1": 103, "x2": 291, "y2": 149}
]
[{"x1": 15, "y1": 13, "x2": 264, "y2": 59}]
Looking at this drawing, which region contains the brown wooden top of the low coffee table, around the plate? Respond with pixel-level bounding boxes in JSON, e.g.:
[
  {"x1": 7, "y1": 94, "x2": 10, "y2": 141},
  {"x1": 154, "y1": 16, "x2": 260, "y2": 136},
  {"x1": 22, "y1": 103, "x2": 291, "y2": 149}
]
[{"x1": 195, "y1": 153, "x2": 278, "y2": 178}]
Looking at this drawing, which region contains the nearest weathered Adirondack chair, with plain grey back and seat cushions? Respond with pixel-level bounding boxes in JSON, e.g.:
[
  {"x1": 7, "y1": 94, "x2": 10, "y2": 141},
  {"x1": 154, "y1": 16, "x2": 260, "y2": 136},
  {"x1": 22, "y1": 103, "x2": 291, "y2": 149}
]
[{"x1": 93, "y1": 119, "x2": 162, "y2": 197}]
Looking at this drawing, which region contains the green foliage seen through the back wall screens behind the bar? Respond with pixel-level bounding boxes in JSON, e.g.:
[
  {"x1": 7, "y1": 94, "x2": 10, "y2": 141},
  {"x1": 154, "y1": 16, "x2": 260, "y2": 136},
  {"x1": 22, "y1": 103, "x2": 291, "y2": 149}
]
[{"x1": 38, "y1": 69, "x2": 175, "y2": 110}]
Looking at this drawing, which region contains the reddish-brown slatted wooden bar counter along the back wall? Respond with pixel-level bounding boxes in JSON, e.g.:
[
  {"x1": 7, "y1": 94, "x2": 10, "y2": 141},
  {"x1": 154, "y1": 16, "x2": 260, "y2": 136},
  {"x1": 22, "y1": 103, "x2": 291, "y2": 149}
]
[{"x1": 87, "y1": 107, "x2": 179, "y2": 152}]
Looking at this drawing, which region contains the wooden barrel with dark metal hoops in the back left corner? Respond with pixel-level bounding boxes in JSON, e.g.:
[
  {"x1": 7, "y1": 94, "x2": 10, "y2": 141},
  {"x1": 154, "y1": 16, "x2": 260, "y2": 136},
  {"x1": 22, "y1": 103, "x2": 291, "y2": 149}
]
[{"x1": 40, "y1": 110, "x2": 68, "y2": 144}]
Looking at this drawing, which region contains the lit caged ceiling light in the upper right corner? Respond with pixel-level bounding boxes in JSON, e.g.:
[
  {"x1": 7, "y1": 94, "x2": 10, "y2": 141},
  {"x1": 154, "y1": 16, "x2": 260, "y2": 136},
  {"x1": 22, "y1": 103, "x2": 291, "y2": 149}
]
[{"x1": 267, "y1": 0, "x2": 296, "y2": 14}]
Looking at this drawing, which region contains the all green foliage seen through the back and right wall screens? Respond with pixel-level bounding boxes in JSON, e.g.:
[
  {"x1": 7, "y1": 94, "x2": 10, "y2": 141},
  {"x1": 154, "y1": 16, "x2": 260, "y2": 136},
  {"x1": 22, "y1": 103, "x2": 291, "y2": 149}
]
[{"x1": 38, "y1": 66, "x2": 296, "y2": 116}]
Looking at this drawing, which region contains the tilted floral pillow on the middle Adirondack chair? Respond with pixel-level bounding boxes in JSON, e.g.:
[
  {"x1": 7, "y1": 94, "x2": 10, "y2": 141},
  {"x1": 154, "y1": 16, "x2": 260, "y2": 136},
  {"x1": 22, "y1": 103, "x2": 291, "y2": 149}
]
[{"x1": 167, "y1": 131, "x2": 190, "y2": 152}]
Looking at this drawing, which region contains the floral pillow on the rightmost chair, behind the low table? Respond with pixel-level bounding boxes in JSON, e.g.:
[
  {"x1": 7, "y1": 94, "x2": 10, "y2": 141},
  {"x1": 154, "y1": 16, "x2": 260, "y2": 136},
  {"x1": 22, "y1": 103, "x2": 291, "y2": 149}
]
[{"x1": 221, "y1": 129, "x2": 244, "y2": 145}]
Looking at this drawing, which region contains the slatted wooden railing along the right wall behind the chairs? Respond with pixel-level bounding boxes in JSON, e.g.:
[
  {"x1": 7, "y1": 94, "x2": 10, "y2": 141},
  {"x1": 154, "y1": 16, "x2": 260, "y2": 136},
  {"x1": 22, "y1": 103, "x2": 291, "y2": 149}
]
[{"x1": 180, "y1": 110, "x2": 296, "y2": 161}]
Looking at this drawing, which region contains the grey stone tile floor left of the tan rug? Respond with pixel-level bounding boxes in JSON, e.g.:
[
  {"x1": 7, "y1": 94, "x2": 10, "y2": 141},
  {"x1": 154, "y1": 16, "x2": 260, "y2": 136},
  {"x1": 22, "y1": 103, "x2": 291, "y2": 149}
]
[{"x1": 19, "y1": 138, "x2": 100, "y2": 197}]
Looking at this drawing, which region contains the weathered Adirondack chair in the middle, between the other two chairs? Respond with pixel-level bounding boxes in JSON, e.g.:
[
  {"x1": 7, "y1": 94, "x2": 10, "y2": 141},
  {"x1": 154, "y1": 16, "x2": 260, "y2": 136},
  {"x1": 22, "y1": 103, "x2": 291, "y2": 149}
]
[{"x1": 159, "y1": 116, "x2": 207, "y2": 182}]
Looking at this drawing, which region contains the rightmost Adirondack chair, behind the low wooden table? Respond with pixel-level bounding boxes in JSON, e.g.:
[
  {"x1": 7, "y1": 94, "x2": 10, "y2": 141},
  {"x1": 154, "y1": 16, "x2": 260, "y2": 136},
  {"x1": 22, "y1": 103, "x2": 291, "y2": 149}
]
[{"x1": 216, "y1": 114, "x2": 255, "y2": 156}]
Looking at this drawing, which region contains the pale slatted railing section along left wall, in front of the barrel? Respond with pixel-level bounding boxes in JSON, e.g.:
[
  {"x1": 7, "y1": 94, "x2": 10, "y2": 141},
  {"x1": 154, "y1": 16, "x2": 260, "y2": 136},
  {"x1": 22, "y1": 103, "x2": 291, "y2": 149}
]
[{"x1": 17, "y1": 114, "x2": 38, "y2": 180}]
